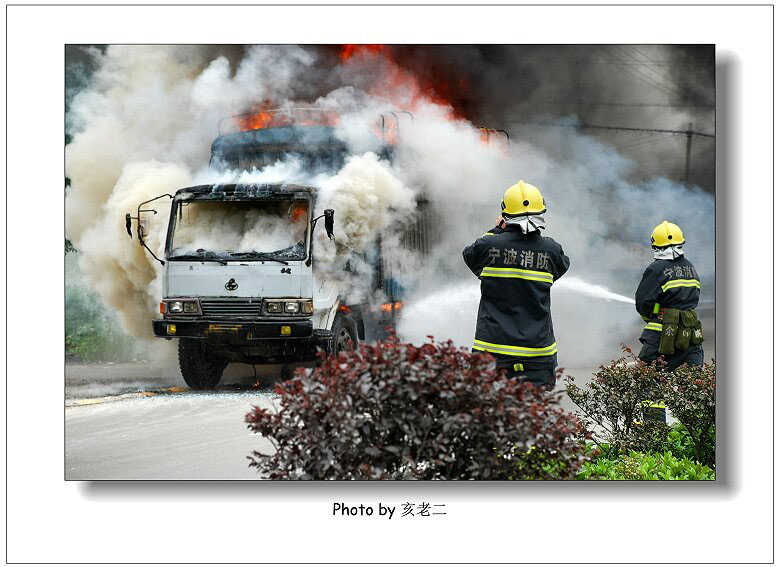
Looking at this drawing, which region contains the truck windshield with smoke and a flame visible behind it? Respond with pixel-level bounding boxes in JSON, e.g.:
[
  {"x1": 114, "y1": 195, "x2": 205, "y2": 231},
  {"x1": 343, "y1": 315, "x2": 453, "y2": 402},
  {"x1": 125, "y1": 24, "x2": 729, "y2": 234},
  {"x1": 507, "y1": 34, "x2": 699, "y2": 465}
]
[{"x1": 168, "y1": 199, "x2": 309, "y2": 261}]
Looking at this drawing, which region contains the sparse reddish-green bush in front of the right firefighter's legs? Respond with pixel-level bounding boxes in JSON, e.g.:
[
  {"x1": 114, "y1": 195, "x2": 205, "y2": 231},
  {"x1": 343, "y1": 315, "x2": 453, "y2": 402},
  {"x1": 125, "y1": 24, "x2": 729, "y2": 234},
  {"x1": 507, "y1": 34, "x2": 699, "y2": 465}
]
[{"x1": 566, "y1": 345, "x2": 668, "y2": 455}]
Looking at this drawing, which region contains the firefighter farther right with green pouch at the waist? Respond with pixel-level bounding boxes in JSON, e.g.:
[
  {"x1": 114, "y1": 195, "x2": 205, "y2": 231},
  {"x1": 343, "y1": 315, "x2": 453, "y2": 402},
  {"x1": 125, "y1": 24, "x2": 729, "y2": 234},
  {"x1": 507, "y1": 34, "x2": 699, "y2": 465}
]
[{"x1": 636, "y1": 221, "x2": 704, "y2": 421}]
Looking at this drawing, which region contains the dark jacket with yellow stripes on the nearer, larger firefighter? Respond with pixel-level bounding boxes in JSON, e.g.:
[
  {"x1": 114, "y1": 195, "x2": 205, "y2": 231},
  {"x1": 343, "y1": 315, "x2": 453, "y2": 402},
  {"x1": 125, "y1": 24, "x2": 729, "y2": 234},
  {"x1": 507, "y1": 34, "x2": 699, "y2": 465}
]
[{"x1": 463, "y1": 225, "x2": 569, "y2": 370}]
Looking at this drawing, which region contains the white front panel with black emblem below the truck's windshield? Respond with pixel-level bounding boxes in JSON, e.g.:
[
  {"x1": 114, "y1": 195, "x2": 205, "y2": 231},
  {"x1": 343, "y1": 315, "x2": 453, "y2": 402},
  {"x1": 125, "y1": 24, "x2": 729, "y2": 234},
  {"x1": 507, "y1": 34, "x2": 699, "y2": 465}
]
[{"x1": 163, "y1": 260, "x2": 312, "y2": 297}]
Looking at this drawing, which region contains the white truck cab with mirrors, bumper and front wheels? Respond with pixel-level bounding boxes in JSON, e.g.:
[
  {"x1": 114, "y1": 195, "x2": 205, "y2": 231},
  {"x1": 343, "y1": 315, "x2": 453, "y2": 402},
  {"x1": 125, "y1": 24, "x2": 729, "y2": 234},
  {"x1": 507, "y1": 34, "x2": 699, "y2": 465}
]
[{"x1": 126, "y1": 184, "x2": 365, "y2": 389}]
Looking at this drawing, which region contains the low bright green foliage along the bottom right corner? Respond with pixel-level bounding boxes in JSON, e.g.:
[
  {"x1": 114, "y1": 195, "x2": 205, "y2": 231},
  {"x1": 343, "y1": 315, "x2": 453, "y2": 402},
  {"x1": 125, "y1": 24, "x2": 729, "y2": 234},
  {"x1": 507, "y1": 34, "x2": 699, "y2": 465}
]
[{"x1": 576, "y1": 451, "x2": 715, "y2": 480}]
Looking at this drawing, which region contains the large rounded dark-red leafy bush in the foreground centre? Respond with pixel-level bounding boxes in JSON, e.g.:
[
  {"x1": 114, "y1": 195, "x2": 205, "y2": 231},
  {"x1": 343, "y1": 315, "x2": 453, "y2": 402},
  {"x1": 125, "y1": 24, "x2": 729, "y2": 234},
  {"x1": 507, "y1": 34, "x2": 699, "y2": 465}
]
[{"x1": 246, "y1": 335, "x2": 584, "y2": 479}]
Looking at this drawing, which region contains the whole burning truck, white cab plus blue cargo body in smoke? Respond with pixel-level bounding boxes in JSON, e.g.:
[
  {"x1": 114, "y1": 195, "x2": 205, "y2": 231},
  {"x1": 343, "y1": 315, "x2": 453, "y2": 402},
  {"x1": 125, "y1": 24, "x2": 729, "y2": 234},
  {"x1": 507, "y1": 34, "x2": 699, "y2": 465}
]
[{"x1": 125, "y1": 109, "x2": 420, "y2": 389}]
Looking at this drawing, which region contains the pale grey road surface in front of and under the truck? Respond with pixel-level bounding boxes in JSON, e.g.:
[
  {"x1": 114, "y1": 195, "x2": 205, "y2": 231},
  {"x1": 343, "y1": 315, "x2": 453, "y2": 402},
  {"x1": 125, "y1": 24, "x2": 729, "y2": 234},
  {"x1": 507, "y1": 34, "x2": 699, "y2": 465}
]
[{"x1": 65, "y1": 312, "x2": 714, "y2": 480}]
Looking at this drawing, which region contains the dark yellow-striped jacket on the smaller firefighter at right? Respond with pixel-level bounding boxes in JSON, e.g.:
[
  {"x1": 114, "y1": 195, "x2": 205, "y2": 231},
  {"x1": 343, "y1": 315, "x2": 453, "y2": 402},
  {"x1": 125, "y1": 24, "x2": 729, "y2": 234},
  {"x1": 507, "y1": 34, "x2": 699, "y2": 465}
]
[{"x1": 636, "y1": 256, "x2": 701, "y2": 353}]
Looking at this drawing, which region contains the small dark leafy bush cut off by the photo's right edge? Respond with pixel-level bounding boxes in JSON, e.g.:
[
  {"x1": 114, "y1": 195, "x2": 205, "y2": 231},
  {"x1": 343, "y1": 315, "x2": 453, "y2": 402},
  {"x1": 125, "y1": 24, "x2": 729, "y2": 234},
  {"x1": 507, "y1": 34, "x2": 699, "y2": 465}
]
[{"x1": 661, "y1": 360, "x2": 715, "y2": 466}]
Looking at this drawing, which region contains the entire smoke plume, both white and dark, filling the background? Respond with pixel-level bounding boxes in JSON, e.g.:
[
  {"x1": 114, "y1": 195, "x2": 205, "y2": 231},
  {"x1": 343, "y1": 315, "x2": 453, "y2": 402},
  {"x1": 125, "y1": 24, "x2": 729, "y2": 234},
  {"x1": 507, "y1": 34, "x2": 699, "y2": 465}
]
[{"x1": 66, "y1": 46, "x2": 714, "y2": 364}]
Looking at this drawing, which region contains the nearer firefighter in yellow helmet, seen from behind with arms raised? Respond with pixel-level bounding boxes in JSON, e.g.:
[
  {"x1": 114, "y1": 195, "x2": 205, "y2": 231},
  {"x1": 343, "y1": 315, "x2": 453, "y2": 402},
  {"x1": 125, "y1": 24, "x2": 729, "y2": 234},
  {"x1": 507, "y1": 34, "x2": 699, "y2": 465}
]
[{"x1": 463, "y1": 181, "x2": 569, "y2": 390}]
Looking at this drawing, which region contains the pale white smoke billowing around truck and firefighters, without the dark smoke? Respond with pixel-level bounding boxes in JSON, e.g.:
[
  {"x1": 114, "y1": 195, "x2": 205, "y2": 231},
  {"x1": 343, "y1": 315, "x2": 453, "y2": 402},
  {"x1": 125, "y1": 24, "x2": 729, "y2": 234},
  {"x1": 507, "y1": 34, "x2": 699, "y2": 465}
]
[{"x1": 66, "y1": 46, "x2": 714, "y2": 364}]
